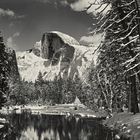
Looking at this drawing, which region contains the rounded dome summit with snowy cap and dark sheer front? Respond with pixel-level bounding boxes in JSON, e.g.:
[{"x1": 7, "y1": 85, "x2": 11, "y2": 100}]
[{"x1": 41, "y1": 32, "x2": 79, "y2": 60}]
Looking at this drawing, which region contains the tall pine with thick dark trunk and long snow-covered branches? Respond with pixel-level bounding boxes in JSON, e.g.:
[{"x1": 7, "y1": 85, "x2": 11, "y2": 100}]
[{"x1": 89, "y1": 0, "x2": 140, "y2": 113}]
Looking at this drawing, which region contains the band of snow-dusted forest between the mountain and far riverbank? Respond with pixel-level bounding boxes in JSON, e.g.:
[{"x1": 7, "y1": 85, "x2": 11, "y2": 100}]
[{"x1": 6, "y1": 72, "x2": 96, "y2": 109}]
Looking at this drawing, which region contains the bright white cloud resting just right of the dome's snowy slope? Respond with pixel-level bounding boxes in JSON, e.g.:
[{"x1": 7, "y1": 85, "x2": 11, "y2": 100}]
[{"x1": 80, "y1": 33, "x2": 103, "y2": 47}]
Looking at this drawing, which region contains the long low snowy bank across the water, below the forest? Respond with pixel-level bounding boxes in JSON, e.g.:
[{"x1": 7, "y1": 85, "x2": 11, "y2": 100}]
[{"x1": 0, "y1": 104, "x2": 99, "y2": 118}]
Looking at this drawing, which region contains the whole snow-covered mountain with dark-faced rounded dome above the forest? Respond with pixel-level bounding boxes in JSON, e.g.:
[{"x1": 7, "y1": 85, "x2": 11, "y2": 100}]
[{"x1": 16, "y1": 31, "x2": 95, "y2": 82}]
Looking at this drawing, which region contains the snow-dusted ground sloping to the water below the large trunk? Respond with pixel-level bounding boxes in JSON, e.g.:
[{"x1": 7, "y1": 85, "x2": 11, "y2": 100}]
[{"x1": 105, "y1": 113, "x2": 140, "y2": 140}]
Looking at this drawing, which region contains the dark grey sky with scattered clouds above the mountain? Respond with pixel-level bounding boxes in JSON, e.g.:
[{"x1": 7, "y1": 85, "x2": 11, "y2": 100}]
[{"x1": 0, "y1": 0, "x2": 106, "y2": 51}]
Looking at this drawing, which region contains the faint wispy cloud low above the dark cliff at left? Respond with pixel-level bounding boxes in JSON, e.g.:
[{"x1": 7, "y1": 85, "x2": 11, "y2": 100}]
[{"x1": 6, "y1": 32, "x2": 20, "y2": 50}]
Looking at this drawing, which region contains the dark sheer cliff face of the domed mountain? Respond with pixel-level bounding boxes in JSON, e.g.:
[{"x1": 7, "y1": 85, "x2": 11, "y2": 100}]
[{"x1": 41, "y1": 33, "x2": 76, "y2": 77}]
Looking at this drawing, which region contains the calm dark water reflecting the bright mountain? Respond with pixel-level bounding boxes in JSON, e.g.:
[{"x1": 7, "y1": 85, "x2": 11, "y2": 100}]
[{"x1": 0, "y1": 112, "x2": 112, "y2": 140}]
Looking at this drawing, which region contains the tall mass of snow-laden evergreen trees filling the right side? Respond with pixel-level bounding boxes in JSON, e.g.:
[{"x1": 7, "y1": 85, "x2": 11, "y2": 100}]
[{"x1": 87, "y1": 0, "x2": 140, "y2": 113}]
